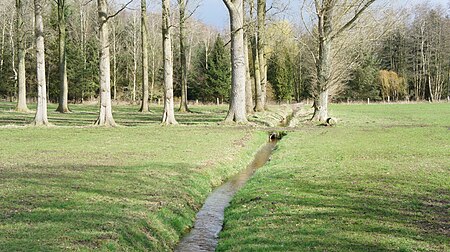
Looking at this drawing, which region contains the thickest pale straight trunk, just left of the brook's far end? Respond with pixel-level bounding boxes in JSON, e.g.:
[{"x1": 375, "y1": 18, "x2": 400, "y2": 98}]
[{"x1": 223, "y1": 0, "x2": 247, "y2": 123}]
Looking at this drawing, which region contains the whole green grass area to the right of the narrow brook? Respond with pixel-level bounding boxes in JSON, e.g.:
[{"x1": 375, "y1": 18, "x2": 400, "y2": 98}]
[{"x1": 218, "y1": 104, "x2": 450, "y2": 251}]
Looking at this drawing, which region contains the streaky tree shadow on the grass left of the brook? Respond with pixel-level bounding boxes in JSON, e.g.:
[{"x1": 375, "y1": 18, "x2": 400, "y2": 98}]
[{"x1": 0, "y1": 162, "x2": 209, "y2": 251}]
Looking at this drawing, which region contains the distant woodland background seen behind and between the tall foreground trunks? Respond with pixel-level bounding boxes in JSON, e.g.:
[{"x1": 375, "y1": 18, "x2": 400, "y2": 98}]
[{"x1": 0, "y1": 0, "x2": 450, "y2": 103}]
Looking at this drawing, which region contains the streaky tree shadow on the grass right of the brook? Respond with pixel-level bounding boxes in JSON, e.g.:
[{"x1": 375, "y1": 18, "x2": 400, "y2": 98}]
[{"x1": 219, "y1": 174, "x2": 450, "y2": 251}]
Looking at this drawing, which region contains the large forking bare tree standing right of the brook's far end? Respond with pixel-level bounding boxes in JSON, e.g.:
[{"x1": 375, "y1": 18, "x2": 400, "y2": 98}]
[{"x1": 312, "y1": 0, "x2": 375, "y2": 122}]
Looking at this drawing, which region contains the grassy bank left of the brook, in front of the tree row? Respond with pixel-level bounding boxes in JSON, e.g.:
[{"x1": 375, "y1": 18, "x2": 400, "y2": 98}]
[{"x1": 0, "y1": 124, "x2": 267, "y2": 251}]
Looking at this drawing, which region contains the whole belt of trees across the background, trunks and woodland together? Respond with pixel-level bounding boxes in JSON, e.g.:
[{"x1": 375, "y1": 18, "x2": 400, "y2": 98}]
[{"x1": 0, "y1": 0, "x2": 450, "y2": 125}]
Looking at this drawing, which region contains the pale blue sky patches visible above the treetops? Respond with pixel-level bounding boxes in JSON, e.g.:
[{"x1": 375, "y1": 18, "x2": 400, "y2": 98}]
[{"x1": 194, "y1": 0, "x2": 450, "y2": 30}]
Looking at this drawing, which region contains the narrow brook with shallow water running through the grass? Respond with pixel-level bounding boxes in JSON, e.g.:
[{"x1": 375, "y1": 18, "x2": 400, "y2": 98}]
[{"x1": 175, "y1": 139, "x2": 277, "y2": 252}]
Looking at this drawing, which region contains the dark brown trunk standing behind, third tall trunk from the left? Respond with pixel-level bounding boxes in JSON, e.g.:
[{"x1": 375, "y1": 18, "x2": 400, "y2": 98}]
[{"x1": 56, "y1": 0, "x2": 70, "y2": 113}]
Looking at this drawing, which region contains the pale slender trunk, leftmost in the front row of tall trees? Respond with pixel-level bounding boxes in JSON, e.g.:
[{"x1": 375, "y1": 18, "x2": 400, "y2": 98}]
[{"x1": 33, "y1": 0, "x2": 48, "y2": 126}]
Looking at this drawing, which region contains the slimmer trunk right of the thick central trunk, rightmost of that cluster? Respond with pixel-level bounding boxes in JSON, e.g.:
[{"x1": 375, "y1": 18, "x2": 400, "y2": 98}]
[{"x1": 256, "y1": 0, "x2": 267, "y2": 109}]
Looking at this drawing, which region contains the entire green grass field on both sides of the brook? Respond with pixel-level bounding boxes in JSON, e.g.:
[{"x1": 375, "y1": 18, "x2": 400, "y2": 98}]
[{"x1": 0, "y1": 103, "x2": 450, "y2": 251}]
